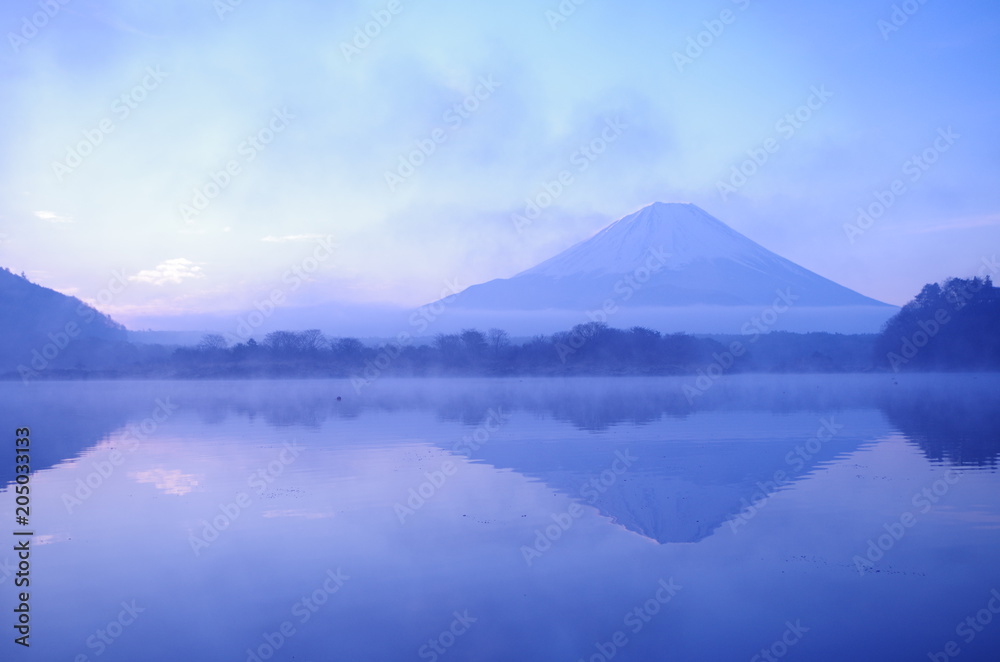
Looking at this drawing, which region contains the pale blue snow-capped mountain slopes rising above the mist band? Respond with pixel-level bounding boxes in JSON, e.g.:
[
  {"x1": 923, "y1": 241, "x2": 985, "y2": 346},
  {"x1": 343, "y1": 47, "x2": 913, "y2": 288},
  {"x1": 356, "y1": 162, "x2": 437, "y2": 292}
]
[{"x1": 453, "y1": 202, "x2": 892, "y2": 311}]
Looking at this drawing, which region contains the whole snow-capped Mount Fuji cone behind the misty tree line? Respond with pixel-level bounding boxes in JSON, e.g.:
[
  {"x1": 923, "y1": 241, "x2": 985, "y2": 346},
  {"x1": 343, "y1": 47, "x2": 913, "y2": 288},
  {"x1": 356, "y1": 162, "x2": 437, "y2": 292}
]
[{"x1": 426, "y1": 202, "x2": 897, "y2": 333}]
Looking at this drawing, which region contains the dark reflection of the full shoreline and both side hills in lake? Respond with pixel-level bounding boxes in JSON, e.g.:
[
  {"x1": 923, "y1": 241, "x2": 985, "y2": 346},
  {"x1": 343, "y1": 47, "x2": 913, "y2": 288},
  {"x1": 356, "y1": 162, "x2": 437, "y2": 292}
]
[{"x1": 0, "y1": 373, "x2": 1000, "y2": 490}]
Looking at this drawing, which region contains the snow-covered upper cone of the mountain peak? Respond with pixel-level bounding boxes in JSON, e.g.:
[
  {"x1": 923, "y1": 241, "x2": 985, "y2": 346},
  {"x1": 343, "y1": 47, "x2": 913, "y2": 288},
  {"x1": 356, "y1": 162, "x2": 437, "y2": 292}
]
[{"x1": 519, "y1": 202, "x2": 784, "y2": 278}]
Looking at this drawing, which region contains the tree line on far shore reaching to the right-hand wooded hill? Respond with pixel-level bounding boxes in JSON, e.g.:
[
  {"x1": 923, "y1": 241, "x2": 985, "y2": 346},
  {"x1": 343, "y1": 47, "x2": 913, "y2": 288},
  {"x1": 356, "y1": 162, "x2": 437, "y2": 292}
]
[{"x1": 171, "y1": 322, "x2": 888, "y2": 382}]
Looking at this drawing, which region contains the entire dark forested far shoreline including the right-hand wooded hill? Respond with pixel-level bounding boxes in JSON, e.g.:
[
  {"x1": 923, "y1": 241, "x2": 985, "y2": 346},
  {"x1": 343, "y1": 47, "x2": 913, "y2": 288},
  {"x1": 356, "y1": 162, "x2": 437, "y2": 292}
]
[{"x1": 3, "y1": 278, "x2": 1000, "y2": 384}]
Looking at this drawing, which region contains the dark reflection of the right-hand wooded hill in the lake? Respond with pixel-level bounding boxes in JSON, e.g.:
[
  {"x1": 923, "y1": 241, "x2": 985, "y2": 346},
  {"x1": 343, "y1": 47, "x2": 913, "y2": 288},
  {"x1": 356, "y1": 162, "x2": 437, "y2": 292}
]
[{"x1": 879, "y1": 374, "x2": 1000, "y2": 469}]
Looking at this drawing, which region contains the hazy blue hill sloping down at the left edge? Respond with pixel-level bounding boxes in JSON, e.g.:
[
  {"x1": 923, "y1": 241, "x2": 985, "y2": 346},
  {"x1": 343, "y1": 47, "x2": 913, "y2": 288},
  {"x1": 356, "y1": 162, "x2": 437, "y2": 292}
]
[{"x1": 0, "y1": 267, "x2": 127, "y2": 372}]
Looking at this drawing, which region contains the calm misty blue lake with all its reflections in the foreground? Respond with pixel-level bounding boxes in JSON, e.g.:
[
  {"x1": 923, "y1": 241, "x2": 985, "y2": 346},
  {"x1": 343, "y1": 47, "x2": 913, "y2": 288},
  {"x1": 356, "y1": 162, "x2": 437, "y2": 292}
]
[{"x1": 0, "y1": 375, "x2": 1000, "y2": 662}]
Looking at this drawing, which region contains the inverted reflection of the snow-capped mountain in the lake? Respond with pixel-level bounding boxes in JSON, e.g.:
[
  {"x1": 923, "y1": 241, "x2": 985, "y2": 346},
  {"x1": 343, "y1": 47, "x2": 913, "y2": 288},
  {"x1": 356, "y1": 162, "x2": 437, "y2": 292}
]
[{"x1": 450, "y1": 410, "x2": 888, "y2": 543}]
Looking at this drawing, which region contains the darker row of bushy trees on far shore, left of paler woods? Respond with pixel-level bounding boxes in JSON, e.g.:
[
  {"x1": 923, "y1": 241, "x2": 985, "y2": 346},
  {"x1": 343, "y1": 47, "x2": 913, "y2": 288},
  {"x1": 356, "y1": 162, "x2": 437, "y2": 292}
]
[{"x1": 174, "y1": 322, "x2": 740, "y2": 378}]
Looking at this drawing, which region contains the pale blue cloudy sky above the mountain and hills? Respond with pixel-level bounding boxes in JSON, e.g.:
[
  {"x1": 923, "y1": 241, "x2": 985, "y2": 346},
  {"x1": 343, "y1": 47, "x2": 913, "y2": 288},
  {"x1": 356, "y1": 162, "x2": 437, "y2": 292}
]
[{"x1": 0, "y1": 0, "x2": 1000, "y2": 326}]
